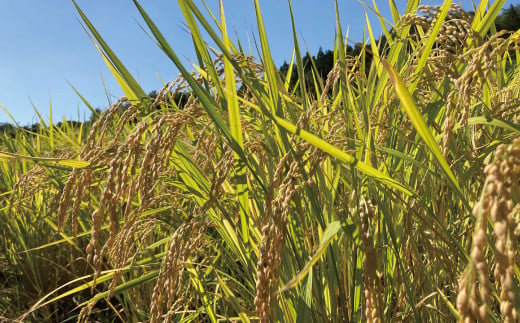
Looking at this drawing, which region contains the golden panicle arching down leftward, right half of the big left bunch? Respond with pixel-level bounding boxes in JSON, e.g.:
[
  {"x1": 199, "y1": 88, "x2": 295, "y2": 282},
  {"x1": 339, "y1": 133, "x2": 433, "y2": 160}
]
[{"x1": 100, "y1": 108, "x2": 202, "y2": 293}]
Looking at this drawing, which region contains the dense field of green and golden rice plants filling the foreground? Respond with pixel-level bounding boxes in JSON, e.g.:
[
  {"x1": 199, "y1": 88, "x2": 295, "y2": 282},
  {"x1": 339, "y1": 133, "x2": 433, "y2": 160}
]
[{"x1": 0, "y1": 0, "x2": 520, "y2": 322}]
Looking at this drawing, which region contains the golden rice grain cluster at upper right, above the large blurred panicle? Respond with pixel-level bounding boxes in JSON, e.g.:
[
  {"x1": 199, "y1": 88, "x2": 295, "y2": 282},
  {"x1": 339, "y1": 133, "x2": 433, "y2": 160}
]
[{"x1": 400, "y1": 4, "x2": 520, "y2": 158}]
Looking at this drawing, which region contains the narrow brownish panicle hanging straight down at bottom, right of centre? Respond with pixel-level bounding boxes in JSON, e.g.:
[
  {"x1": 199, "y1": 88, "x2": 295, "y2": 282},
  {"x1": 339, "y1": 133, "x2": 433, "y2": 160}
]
[{"x1": 359, "y1": 200, "x2": 382, "y2": 323}]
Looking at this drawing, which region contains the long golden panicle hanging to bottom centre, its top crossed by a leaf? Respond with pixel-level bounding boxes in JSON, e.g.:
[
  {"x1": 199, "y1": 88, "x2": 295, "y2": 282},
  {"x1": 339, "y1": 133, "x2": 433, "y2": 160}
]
[{"x1": 254, "y1": 104, "x2": 341, "y2": 322}]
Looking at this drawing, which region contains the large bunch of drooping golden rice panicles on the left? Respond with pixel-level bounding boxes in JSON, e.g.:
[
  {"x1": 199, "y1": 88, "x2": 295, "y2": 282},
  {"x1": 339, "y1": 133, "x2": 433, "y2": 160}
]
[{"x1": 54, "y1": 85, "x2": 205, "y2": 292}]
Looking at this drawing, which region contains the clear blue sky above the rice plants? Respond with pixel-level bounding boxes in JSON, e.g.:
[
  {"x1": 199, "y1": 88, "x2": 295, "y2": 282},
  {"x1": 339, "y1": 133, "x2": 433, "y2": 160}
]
[{"x1": 0, "y1": 0, "x2": 510, "y2": 125}]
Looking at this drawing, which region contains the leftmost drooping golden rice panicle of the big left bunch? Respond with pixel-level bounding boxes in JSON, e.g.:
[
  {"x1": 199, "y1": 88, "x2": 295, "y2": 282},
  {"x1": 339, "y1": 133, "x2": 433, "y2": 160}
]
[{"x1": 61, "y1": 98, "x2": 146, "y2": 322}]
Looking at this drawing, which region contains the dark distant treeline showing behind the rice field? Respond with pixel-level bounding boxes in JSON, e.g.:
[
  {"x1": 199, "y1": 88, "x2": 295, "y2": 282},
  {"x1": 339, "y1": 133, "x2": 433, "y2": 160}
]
[{"x1": 0, "y1": 4, "x2": 520, "y2": 136}]
